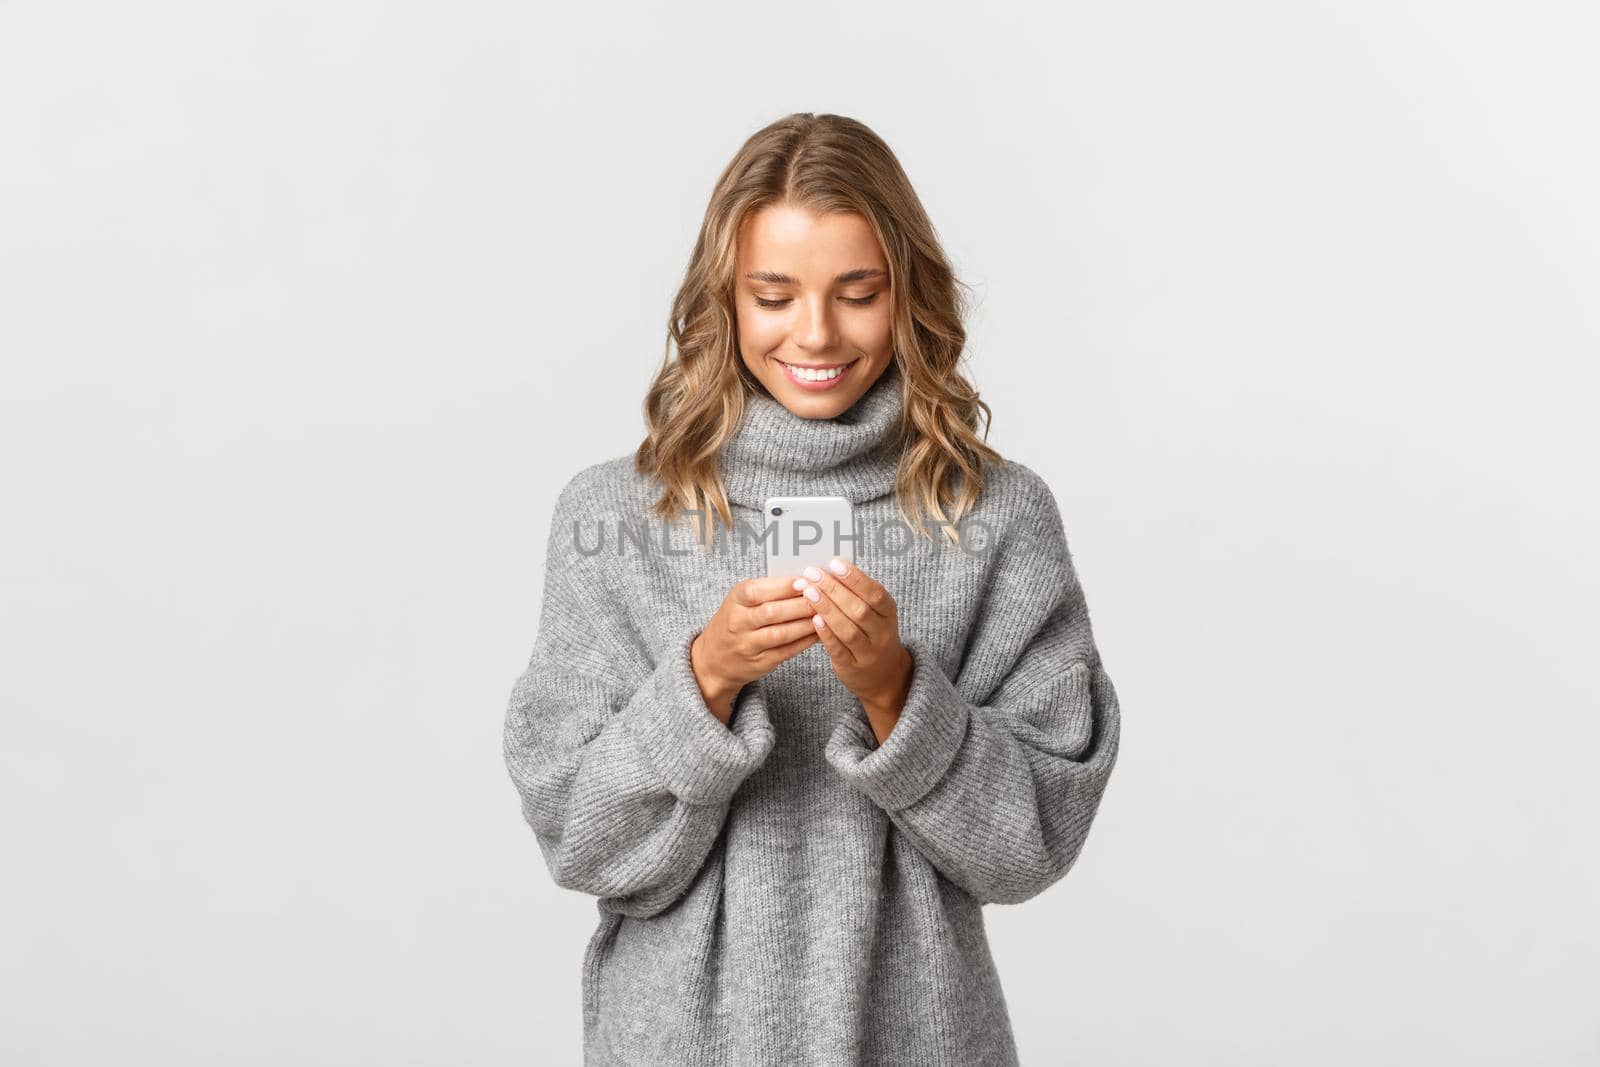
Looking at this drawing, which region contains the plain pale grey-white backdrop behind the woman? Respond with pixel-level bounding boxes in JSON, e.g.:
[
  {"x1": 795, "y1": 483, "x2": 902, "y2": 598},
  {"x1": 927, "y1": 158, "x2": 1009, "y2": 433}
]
[{"x1": 0, "y1": 0, "x2": 1600, "y2": 1067}]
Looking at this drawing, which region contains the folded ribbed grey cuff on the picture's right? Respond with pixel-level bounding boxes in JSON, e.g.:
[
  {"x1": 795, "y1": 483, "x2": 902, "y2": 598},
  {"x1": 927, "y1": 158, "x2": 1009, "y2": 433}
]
[{"x1": 824, "y1": 640, "x2": 970, "y2": 811}]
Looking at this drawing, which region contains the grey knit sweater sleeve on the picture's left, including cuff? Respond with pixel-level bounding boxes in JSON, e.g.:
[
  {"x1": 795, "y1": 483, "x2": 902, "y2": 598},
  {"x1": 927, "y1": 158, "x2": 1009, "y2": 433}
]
[{"x1": 504, "y1": 475, "x2": 776, "y2": 917}]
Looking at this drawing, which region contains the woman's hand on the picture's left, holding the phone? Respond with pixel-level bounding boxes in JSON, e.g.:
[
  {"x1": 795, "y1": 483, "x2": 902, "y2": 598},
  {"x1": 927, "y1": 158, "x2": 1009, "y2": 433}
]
[{"x1": 690, "y1": 577, "x2": 821, "y2": 726}]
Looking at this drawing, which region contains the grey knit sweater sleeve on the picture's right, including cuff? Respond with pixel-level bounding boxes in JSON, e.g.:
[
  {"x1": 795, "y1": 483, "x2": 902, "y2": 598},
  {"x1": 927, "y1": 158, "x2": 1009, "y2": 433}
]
[{"x1": 826, "y1": 469, "x2": 1122, "y2": 904}]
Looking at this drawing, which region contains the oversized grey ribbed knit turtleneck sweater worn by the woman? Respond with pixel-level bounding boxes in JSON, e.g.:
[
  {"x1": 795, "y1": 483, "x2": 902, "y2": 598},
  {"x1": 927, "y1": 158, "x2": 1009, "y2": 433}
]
[{"x1": 504, "y1": 366, "x2": 1120, "y2": 1067}]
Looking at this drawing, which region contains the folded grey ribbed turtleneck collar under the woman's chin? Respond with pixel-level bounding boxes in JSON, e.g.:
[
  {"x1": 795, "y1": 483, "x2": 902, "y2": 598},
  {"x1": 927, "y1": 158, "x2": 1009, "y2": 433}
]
[{"x1": 722, "y1": 363, "x2": 904, "y2": 510}]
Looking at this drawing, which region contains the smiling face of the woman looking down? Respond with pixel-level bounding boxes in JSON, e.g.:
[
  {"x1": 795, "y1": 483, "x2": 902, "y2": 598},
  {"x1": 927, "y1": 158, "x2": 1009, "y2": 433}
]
[{"x1": 734, "y1": 205, "x2": 894, "y2": 419}]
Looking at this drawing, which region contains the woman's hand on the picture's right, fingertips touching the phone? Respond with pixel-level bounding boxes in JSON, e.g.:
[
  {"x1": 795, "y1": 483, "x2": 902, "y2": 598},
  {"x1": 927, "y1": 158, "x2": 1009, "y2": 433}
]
[{"x1": 794, "y1": 558, "x2": 912, "y2": 744}]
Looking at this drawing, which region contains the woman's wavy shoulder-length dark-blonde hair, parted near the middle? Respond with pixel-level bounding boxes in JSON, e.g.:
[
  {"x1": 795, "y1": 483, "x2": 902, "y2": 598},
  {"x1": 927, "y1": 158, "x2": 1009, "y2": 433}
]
[{"x1": 634, "y1": 112, "x2": 1000, "y2": 542}]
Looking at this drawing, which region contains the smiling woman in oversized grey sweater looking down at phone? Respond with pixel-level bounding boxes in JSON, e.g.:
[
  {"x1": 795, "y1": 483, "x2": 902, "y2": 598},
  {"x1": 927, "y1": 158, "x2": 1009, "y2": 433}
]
[{"x1": 506, "y1": 114, "x2": 1120, "y2": 1067}]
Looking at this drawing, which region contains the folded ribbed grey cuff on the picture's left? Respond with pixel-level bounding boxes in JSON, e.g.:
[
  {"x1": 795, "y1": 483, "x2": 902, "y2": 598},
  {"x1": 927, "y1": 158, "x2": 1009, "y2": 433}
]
[{"x1": 622, "y1": 632, "x2": 778, "y2": 805}]
